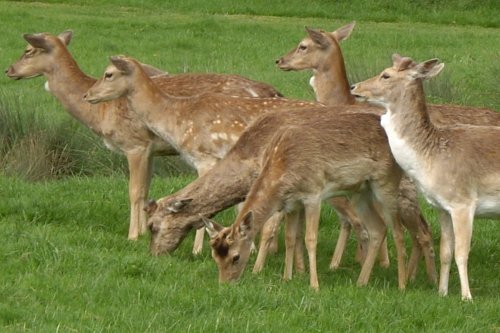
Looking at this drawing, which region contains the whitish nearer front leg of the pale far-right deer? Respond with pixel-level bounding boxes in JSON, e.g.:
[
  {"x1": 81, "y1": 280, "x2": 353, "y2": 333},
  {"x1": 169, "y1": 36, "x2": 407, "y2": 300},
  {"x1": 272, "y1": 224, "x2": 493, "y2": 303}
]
[{"x1": 451, "y1": 207, "x2": 474, "y2": 301}]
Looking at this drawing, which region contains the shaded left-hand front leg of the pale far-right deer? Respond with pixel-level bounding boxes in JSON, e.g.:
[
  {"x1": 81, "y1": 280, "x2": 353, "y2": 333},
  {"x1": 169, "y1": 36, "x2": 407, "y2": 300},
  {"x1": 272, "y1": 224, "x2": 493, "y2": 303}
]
[{"x1": 439, "y1": 211, "x2": 455, "y2": 296}]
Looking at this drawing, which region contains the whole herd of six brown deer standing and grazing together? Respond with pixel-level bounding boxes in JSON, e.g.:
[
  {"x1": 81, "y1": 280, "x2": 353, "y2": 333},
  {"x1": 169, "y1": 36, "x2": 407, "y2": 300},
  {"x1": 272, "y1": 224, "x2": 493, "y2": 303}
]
[{"x1": 6, "y1": 22, "x2": 500, "y2": 300}]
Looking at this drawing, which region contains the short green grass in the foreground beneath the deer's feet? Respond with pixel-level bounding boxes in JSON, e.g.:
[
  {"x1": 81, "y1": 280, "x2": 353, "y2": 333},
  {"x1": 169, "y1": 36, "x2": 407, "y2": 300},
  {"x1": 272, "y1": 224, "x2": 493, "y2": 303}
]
[{"x1": 0, "y1": 176, "x2": 500, "y2": 332}]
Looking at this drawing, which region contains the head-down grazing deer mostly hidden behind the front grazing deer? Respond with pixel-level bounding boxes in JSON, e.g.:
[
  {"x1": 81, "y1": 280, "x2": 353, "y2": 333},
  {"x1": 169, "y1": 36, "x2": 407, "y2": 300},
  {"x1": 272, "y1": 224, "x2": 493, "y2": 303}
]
[{"x1": 148, "y1": 105, "x2": 412, "y2": 287}]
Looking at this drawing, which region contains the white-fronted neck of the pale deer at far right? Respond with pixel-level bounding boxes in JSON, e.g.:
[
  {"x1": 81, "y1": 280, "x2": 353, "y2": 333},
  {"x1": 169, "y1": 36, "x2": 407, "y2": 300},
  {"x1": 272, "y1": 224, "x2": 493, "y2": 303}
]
[{"x1": 380, "y1": 81, "x2": 439, "y2": 179}]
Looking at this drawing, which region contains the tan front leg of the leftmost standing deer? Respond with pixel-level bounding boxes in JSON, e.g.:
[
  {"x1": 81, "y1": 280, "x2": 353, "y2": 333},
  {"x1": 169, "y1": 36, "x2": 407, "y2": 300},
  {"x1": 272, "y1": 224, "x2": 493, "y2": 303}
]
[{"x1": 127, "y1": 147, "x2": 153, "y2": 240}]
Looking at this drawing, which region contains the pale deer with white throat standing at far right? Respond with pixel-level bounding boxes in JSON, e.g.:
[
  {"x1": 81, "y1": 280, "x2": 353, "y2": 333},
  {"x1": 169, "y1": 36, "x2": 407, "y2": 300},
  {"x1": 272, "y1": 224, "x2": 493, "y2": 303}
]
[{"x1": 352, "y1": 54, "x2": 500, "y2": 301}]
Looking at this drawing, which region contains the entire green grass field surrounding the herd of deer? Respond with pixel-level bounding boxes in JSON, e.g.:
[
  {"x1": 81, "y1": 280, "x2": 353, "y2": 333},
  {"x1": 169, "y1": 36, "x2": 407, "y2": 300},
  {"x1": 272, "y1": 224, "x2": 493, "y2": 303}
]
[{"x1": 0, "y1": 0, "x2": 500, "y2": 332}]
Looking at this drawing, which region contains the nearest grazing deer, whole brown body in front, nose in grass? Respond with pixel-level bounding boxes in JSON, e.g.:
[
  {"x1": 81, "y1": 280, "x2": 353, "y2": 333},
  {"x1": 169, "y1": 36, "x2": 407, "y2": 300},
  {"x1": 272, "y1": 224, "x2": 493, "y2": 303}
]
[{"x1": 207, "y1": 109, "x2": 406, "y2": 289}]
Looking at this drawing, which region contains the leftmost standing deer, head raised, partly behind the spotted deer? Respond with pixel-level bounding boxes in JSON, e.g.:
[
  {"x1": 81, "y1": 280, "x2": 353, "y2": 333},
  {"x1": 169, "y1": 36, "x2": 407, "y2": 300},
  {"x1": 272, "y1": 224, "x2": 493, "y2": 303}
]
[{"x1": 5, "y1": 31, "x2": 281, "y2": 244}]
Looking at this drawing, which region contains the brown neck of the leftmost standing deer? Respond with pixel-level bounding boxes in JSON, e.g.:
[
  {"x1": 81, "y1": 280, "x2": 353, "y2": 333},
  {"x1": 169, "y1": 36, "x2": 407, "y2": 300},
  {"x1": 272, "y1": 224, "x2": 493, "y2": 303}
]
[{"x1": 44, "y1": 52, "x2": 105, "y2": 133}]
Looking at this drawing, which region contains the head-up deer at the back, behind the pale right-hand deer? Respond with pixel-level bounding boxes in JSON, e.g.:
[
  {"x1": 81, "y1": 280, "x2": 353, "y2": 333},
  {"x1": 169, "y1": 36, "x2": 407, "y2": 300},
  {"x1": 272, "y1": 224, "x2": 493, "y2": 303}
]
[{"x1": 276, "y1": 22, "x2": 500, "y2": 280}]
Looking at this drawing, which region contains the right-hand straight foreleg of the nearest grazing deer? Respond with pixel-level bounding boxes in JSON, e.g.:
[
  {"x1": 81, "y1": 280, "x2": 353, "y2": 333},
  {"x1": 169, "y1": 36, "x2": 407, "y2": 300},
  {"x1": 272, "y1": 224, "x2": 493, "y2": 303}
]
[{"x1": 304, "y1": 200, "x2": 321, "y2": 290}]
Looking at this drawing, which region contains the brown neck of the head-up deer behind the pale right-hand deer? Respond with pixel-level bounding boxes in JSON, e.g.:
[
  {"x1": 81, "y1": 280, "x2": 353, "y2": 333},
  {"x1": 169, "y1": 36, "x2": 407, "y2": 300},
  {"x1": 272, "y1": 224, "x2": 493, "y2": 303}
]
[{"x1": 313, "y1": 53, "x2": 355, "y2": 105}]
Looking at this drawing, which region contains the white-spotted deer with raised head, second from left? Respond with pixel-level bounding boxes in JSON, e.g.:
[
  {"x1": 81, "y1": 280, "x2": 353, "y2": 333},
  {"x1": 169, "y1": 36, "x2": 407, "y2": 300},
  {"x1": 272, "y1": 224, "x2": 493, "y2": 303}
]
[{"x1": 84, "y1": 56, "x2": 320, "y2": 252}]
